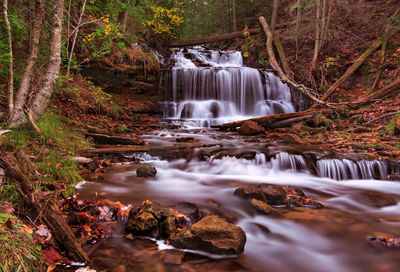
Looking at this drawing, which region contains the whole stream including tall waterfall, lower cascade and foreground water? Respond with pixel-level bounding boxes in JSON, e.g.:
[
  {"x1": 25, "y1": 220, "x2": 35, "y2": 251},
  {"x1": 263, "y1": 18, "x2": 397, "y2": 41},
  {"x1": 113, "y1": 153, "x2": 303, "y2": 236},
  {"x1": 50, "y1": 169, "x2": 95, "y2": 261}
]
[{"x1": 80, "y1": 47, "x2": 400, "y2": 271}]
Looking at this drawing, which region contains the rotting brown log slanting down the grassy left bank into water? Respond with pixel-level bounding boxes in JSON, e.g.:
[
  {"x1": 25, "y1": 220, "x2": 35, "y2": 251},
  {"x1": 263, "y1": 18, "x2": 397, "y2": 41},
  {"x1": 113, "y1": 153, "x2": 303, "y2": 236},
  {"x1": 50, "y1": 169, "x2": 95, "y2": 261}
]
[{"x1": 0, "y1": 152, "x2": 89, "y2": 262}]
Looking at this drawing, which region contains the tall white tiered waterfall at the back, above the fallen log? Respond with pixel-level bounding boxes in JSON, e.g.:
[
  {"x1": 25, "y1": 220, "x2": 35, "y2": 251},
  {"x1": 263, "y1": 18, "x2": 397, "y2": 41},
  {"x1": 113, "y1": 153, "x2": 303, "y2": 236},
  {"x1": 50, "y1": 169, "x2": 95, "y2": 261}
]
[{"x1": 163, "y1": 47, "x2": 295, "y2": 127}]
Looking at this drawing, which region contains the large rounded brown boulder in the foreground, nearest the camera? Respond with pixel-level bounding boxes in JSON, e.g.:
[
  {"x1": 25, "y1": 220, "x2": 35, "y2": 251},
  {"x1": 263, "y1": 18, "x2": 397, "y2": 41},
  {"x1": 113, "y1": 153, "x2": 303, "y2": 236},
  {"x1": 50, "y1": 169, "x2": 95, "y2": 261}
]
[{"x1": 170, "y1": 215, "x2": 246, "y2": 255}]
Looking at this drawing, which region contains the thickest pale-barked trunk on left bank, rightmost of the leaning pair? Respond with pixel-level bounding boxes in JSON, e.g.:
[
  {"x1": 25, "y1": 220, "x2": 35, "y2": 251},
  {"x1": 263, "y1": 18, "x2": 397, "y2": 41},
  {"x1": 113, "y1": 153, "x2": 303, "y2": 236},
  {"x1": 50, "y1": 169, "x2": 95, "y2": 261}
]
[{"x1": 28, "y1": 0, "x2": 64, "y2": 120}]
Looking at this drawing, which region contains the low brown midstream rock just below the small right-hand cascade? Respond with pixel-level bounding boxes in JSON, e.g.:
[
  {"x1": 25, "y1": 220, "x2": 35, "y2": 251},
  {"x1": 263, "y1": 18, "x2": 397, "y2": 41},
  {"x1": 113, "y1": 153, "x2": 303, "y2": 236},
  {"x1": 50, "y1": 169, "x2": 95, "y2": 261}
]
[{"x1": 234, "y1": 183, "x2": 286, "y2": 205}]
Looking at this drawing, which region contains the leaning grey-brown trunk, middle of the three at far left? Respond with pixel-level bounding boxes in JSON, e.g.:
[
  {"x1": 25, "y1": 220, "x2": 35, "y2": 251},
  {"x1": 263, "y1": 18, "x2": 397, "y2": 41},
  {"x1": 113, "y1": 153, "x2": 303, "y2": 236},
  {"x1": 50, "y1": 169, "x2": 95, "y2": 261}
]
[{"x1": 10, "y1": 0, "x2": 44, "y2": 127}]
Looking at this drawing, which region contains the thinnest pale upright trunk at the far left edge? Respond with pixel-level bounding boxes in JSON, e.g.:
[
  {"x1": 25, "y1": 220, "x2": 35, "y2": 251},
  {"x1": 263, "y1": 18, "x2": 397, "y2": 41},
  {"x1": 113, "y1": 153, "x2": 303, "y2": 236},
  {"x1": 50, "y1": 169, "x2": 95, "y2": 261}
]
[{"x1": 3, "y1": 0, "x2": 14, "y2": 117}]
